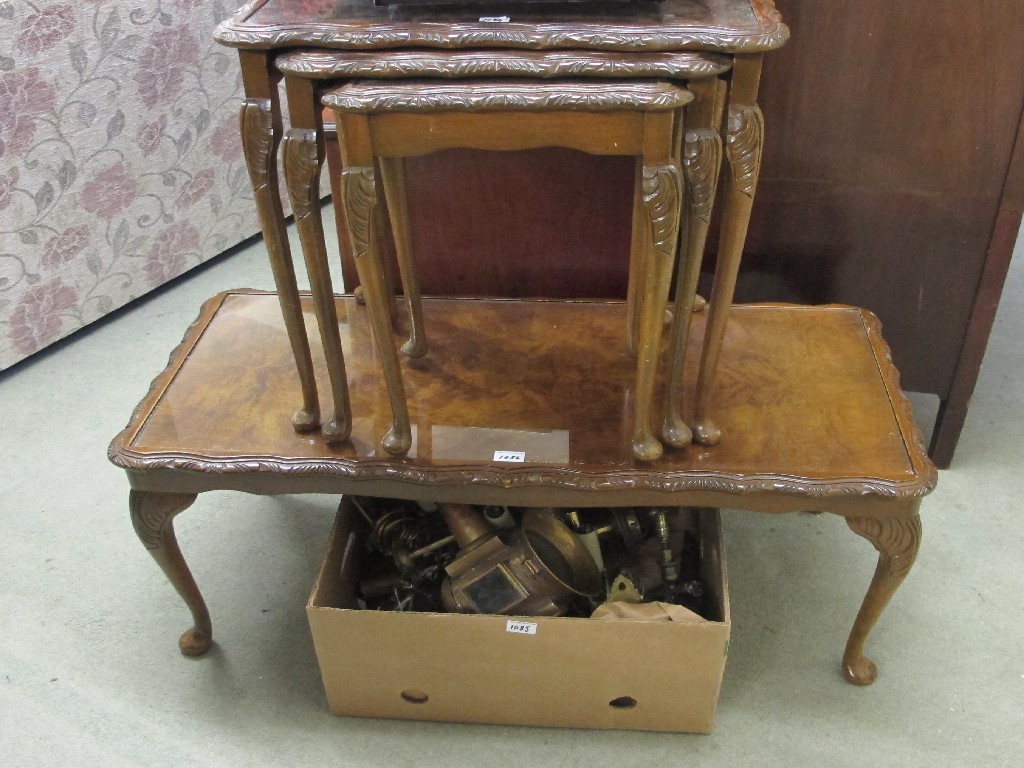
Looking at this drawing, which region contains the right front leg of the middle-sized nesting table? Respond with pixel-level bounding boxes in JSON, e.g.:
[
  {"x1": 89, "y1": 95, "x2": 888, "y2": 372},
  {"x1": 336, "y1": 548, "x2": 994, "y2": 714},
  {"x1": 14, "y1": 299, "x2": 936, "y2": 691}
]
[{"x1": 662, "y1": 78, "x2": 722, "y2": 447}]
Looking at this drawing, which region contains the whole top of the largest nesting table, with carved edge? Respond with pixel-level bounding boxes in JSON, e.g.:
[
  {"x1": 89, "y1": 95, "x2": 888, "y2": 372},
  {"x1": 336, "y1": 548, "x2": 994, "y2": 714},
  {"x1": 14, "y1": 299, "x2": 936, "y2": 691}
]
[{"x1": 214, "y1": 0, "x2": 790, "y2": 53}]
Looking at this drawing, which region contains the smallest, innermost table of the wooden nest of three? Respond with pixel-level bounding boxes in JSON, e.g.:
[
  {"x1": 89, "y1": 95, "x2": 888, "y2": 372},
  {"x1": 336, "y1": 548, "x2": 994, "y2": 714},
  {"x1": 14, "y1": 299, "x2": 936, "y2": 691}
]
[{"x1": 319, "y1": 79, "x2": 693, "y2": 461}]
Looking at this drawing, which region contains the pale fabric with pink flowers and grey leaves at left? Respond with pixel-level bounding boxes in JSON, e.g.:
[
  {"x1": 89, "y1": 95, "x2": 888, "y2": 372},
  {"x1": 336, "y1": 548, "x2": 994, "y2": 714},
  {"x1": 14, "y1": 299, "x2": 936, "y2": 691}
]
[{"x1": 0, "y1": 0, "x2": 257, "y2": 369}]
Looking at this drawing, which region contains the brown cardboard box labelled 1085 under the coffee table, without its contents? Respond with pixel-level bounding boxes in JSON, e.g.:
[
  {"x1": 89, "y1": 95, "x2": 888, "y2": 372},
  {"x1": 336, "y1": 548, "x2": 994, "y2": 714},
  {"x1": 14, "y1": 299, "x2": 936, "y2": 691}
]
[{"x1": 306, "y1": 501, "x2": 730, "y2": 733}]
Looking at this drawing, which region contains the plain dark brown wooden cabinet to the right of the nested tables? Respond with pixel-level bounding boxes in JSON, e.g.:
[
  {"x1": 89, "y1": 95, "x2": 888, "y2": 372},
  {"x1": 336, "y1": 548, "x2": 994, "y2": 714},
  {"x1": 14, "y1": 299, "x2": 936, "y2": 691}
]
[{"x1": 753, "y1": 0, "x2": 1024, "y2": 467}]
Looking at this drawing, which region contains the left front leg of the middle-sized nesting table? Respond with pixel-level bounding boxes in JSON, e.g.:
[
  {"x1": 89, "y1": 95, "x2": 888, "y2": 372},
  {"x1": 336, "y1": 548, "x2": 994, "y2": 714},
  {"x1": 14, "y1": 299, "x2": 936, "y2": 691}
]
[{"x1": 282, "y1": 77, "x2": 352, "y2": 442}]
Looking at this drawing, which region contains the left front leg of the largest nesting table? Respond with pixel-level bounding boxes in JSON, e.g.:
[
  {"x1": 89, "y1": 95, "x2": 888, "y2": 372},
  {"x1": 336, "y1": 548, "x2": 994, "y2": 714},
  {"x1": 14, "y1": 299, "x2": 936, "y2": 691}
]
[{"x1": 239, "y1": 51, "x2": 319, "y2": 432}]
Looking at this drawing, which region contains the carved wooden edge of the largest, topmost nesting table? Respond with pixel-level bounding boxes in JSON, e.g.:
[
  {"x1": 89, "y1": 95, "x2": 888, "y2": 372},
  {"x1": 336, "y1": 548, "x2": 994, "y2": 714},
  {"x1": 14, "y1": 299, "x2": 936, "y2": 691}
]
[{"x1": 213, "y1": 0, "x2": 790, "y2": 53}]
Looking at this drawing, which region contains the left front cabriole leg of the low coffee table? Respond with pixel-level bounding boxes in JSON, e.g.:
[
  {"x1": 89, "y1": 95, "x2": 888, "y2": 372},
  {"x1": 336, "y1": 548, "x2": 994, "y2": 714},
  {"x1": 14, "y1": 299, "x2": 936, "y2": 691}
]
[{"x1": 128, "y1": 489, "x2": 213, "y2": 656}]
